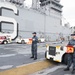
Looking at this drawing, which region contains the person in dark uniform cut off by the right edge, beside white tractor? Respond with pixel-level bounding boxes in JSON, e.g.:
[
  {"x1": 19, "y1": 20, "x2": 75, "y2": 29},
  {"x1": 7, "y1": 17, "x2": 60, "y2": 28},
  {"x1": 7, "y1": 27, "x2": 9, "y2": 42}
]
[{"x1": 64, "y1": 34, "x2": 75, "y2": 74}]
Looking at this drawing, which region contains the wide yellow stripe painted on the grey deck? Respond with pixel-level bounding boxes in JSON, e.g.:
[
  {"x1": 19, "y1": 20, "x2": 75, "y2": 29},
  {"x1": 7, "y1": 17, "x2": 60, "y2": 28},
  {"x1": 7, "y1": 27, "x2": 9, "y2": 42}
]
[{"x1": 0, "y1": 60, "x2": 52, "y2": 75}]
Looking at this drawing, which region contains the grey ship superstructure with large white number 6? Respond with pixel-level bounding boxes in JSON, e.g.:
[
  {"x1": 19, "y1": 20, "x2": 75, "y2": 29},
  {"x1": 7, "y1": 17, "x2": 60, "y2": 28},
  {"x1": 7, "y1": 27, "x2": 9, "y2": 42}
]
[{"x1": 0, "y1": 0, "x2": 71, "y2": 41}]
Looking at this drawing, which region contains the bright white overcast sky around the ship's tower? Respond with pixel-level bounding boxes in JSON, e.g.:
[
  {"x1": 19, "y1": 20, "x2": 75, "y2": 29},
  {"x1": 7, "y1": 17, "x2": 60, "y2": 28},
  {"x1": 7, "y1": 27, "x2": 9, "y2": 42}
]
[{"x1": 26, "y1": 0, "x2": 75, "y2": 27}]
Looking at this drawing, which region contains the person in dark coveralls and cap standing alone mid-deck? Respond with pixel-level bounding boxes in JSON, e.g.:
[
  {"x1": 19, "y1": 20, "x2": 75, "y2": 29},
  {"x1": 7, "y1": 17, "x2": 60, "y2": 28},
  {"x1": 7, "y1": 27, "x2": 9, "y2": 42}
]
[{"x1": 31, "y1": 32, "x2": 38, "y2": 60}]
